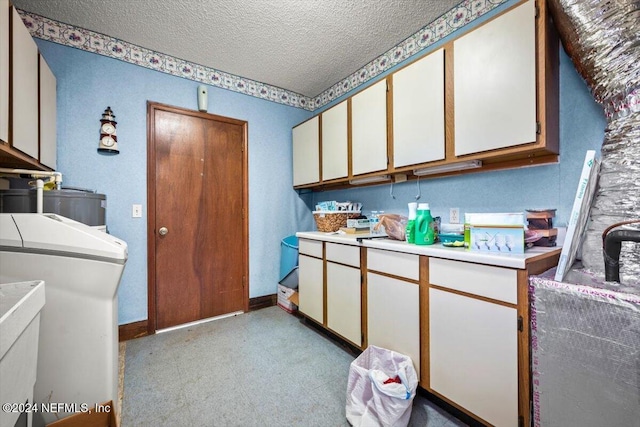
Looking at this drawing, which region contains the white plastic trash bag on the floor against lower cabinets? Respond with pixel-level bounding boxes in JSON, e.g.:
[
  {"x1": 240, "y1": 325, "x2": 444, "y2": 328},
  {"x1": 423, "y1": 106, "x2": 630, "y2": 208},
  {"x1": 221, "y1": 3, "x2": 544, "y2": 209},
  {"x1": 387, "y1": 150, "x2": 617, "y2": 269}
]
[{"x1": 346, "y1": 345, "x2": 418, "y2": 427}]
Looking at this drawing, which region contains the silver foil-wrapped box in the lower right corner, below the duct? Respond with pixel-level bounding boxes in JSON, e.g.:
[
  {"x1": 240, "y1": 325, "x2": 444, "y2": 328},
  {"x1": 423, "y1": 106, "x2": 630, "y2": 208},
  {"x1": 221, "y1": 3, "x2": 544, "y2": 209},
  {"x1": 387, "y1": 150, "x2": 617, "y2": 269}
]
[{"x1": 529, "y1": 268, "x2": 640, "y2": 427}]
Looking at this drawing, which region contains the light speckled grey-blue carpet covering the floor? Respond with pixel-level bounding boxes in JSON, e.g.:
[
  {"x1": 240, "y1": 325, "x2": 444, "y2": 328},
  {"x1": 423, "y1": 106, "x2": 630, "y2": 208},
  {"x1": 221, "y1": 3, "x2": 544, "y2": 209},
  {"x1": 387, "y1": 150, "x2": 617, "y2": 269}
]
[{"x1": 121, "y1": 307, "x2": 465, "y2": 427}]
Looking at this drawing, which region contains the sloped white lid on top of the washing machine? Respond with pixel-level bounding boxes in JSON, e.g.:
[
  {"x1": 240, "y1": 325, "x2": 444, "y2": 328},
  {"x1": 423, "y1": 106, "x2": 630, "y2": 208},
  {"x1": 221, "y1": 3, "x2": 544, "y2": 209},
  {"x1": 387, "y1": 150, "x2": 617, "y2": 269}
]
[{"x1": 11, "y1": 214, "x2": 127, "y2": 263}]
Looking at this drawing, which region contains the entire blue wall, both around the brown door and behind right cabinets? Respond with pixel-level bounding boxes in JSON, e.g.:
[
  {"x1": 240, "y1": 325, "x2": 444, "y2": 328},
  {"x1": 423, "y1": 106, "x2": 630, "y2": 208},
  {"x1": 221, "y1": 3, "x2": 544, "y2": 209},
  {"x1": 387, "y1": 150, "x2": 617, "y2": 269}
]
[{"x1": 37, "y1": 0, "x2": 605, "y2": 324}]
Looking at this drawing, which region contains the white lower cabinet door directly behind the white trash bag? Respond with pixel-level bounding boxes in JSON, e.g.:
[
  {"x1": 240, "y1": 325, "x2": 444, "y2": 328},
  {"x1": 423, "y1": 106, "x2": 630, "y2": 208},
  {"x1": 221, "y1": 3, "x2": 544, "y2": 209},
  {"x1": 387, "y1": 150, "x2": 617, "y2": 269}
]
[{"x1": 367, "y1": 273, "x2": 420, "y2": 378}]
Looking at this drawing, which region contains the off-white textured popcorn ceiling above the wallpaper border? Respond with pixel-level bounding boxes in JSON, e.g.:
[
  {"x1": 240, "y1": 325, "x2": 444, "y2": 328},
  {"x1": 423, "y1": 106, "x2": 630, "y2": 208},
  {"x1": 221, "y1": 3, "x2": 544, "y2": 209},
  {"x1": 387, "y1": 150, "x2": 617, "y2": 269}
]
[{"x1": 12, "y1": 0, "x2": 462, "y2": 97}]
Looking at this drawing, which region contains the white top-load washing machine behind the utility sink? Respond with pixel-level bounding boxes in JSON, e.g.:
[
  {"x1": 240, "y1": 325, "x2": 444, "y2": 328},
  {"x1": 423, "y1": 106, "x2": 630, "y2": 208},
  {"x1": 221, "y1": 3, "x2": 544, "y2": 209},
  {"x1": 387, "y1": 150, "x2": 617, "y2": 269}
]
[{"x1": 0, "y1": 213, "x2": 127, "y2": 425}]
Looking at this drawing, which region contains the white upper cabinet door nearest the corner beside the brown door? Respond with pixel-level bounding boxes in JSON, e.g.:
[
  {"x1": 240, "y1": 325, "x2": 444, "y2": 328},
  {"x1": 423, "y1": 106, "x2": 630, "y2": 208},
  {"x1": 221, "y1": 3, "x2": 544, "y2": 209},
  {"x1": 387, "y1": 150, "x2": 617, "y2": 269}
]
[{"x1": 292, "y1": 116, "x2": 320, "y2": 186}]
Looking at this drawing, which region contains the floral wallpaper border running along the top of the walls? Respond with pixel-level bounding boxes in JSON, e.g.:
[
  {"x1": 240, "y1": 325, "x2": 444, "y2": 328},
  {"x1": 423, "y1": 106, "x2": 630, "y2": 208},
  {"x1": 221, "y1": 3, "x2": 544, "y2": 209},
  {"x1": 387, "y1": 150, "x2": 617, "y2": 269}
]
[{"x1": 19, "y1": 0, "x2": 507, "y2": 111}]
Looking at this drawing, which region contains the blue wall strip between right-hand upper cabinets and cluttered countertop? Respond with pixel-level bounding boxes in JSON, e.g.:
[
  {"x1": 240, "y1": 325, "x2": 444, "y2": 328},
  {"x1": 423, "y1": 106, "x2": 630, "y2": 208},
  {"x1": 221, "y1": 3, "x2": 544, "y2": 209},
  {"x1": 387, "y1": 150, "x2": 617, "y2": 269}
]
[{"x1": 310, "y1": 49, "x2": 606, "y2": 230}]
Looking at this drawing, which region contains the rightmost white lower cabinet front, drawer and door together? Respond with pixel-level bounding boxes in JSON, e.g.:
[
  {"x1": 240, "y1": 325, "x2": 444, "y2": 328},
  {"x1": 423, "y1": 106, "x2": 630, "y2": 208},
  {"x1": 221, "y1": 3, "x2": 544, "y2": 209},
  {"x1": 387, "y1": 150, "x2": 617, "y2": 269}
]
[{"x1": 428, "y1": 258, "x2": 519, "y2": 427}]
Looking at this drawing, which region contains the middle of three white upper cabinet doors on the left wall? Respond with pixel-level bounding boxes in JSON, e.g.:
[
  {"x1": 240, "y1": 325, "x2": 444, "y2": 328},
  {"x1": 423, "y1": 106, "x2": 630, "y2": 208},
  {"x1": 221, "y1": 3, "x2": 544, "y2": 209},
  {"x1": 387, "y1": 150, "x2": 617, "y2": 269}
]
[{"x1": 11, "y1": 8, "x2": 38, "y2": 159}]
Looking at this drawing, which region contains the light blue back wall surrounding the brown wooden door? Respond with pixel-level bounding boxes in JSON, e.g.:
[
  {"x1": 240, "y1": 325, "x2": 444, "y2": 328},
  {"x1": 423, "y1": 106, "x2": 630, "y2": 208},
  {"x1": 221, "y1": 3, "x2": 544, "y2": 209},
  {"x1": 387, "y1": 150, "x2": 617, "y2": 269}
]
[{"x1": 37, "y1": 40, "x2": 313, "y2": 324}]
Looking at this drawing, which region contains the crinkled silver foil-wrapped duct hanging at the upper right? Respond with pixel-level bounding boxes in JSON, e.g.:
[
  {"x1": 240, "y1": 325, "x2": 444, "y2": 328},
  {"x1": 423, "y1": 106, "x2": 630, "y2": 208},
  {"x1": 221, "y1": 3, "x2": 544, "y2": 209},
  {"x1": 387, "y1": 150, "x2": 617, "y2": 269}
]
[{"x1": 548, "y1": 0, "x2": 640, "y2": 282}]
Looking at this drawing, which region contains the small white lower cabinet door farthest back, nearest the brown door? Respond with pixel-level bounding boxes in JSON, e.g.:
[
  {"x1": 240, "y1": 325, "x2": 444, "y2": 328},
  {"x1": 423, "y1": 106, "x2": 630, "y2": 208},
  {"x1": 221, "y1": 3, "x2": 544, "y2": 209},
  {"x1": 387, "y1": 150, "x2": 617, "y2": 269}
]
[{"x1": 298, "y1": 255, "x2": 324, "y2": 323}]
